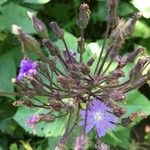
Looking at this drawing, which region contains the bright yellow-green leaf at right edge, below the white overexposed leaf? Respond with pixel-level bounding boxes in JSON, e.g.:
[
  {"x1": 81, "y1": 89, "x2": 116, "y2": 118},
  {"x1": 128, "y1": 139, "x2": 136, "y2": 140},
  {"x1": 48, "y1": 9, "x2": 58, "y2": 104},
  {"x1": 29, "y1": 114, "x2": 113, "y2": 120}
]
[{"x1": 132, "y1": 21, "x2": 150, "y2": 39}]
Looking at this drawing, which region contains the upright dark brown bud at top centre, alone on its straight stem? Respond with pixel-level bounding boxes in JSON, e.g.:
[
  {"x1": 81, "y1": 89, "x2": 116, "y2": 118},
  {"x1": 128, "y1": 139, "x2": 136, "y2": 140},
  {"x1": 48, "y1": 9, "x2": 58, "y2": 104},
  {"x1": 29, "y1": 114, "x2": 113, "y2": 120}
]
[{"x1": 78, "y1": 3, "x2": 91, "y2": 29}]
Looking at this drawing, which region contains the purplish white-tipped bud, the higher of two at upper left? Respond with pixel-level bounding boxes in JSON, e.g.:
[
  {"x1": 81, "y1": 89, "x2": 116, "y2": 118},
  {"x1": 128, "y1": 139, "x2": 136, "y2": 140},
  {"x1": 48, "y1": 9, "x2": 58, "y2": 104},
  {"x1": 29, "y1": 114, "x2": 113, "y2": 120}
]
[{"x1": 27, "y1": 12, "x2": 48, "y2": 38}]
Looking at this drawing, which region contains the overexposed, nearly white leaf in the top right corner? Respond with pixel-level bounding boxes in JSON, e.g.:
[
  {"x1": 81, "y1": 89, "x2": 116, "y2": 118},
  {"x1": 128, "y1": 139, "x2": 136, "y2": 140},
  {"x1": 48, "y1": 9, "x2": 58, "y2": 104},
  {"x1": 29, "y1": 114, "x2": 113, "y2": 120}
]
[{"x1": 132, "y1": 0, "x2": 150, "y2": 18}]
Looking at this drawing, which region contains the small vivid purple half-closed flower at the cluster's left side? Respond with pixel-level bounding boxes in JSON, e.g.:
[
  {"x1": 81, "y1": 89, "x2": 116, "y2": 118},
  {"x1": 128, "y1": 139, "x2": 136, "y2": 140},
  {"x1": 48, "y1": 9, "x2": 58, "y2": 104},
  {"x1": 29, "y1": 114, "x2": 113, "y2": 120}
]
[{"x1": 17, "y1": 58, "x2": 37, "y2": 80}]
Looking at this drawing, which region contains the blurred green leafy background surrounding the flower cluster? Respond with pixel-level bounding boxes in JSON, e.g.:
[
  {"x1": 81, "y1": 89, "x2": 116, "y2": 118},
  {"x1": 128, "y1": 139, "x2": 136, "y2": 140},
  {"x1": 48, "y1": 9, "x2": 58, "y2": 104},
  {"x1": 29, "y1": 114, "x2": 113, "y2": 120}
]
[{"x1": 0, "y1": 0, "x2": 150, "y2": 150}]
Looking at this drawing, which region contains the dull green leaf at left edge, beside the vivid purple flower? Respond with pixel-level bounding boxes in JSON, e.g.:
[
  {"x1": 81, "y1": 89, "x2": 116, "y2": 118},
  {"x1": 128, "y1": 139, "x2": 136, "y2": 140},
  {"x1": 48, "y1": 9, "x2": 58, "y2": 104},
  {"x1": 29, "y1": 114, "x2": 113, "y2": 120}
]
[{"x1": 0, "y1": 52, "x2": 16, "y2": 92}]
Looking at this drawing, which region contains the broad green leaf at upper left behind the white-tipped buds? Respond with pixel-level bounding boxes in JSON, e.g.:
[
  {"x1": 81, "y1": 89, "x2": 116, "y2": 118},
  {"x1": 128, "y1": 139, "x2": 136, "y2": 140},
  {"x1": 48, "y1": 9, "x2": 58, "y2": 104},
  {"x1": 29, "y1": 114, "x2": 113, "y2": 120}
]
[{"x1": 0, "y1": 3, "x2": 35, "y2": 33}]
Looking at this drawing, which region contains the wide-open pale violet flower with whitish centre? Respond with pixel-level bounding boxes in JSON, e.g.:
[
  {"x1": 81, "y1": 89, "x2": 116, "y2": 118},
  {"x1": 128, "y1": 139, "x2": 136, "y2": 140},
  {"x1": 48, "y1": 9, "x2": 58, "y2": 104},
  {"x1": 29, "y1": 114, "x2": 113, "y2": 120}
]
[{"x1": 80, "y1": 99, "x2": 117, "y2": 137}]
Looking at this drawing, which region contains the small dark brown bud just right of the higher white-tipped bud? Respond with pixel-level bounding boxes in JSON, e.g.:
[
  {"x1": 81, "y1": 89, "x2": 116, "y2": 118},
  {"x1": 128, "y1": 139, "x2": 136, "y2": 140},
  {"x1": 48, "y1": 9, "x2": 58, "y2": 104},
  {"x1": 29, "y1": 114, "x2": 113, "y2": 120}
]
[{"x1": 49, "y1": 21, "x2": 64, "y2": 39}]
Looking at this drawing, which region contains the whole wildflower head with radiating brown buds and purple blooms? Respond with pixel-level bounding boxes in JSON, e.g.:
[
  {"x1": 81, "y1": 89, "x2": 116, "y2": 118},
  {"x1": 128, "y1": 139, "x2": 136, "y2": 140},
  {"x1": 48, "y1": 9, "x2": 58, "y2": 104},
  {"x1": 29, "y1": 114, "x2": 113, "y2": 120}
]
[{"x1": 1, "y1": 0, "x2": 150, "y2": 150}]
